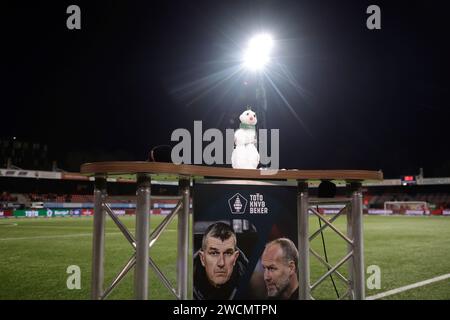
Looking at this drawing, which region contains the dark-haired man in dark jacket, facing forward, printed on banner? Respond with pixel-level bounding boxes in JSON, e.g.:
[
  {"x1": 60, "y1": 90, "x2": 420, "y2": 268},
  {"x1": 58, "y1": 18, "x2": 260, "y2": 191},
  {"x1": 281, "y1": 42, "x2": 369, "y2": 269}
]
[{"x1": 194, "y1": 222, "x2": 248, "y2": 300}]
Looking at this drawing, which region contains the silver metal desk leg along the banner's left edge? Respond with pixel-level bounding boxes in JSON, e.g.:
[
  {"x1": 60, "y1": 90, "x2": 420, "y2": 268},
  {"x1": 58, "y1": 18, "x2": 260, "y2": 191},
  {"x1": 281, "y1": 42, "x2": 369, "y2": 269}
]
[{"x1": 177, "y1": 178, "x2": 190, "y2": 300}]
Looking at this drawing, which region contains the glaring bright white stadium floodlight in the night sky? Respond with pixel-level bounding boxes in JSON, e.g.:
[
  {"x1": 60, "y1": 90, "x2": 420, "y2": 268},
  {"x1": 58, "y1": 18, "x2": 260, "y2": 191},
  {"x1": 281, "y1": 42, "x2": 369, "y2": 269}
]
[{"x1": 244, "y1": 33, "x2": 273, "y2": 71}]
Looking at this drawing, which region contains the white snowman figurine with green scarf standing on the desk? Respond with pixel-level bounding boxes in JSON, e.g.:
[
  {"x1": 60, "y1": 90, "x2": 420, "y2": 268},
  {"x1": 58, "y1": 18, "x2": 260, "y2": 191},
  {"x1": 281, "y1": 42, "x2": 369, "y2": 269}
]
[{"x1": 231, "y1": 107, "x2": 259, "y2": 169}]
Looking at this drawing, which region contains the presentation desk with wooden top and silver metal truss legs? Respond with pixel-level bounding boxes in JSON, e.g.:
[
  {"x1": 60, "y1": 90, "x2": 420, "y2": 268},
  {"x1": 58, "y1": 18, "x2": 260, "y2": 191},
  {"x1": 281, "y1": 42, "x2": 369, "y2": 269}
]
[{"x1": 82, "y1": 163, "x2": 382, "y2": 300}]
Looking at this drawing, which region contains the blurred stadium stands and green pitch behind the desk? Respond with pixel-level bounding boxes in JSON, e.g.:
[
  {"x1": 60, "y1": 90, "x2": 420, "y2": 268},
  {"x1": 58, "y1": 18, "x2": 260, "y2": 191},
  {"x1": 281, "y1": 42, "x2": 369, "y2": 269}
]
[{"x1": 0, "y1": 141, "x2": 450, "y2": 299}]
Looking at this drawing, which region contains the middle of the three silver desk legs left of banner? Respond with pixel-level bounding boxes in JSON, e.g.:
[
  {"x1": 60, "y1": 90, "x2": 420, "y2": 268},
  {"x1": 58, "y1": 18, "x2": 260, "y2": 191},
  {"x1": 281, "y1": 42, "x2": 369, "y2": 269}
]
[{"x1": 134, "y1": 173, "x2": 151, "y2": 300}]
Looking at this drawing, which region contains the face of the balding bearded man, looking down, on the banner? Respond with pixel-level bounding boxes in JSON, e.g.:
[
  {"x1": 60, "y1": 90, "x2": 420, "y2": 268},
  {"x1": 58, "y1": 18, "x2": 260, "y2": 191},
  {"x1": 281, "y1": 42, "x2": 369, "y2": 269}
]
[{"x1": 261, "y1": 244, "x2": 295, "y2": 297}]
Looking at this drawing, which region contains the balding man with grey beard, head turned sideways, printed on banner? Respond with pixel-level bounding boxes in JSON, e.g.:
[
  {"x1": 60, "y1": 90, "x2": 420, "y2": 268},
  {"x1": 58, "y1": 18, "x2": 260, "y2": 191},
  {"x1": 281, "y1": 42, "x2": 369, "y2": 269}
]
[{"x1": 261, "y1": 238, "x2": 299, "y2": 300}]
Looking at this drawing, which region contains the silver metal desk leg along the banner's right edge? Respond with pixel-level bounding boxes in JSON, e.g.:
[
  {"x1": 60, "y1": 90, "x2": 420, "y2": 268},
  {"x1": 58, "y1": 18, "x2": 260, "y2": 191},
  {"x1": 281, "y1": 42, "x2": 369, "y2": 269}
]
[{"x1": 297, "y1": 181, "x2": 311, "y2": 300}]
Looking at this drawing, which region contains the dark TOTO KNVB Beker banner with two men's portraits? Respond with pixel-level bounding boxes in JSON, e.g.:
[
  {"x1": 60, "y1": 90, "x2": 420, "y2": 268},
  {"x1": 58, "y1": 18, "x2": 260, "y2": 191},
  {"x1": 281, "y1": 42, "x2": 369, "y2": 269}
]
[{"x1": 193, "y1": 183, "x2": 298, "y2": 300}]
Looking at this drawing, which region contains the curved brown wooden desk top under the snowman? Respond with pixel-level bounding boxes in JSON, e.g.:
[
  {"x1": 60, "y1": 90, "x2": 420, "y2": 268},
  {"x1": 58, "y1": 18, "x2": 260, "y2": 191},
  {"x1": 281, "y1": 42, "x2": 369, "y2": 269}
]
[{"x1": 81, "y1": 161, "x2": 383, "y2": 181}]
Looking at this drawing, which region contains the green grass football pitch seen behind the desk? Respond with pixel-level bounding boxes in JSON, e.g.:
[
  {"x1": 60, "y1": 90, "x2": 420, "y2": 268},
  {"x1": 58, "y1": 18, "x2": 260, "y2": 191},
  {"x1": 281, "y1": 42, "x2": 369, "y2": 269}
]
[{"x1": 0, "y1": 216, "x2": 450, "y2": 300}]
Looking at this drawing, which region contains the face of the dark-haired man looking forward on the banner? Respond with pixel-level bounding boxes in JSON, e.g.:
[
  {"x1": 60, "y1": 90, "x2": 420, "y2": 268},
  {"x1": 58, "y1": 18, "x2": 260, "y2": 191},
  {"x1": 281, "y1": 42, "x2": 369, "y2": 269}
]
[{"x1": 200, "y1": 237, "x2": 239, "y2": 287}]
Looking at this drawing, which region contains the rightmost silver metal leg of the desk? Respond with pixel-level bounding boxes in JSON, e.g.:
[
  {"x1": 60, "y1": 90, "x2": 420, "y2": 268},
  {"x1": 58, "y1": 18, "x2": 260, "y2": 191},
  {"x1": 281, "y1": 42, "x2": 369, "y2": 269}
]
[{"x1": 350, "y1": 183, "x2": 365, "y2": 300}]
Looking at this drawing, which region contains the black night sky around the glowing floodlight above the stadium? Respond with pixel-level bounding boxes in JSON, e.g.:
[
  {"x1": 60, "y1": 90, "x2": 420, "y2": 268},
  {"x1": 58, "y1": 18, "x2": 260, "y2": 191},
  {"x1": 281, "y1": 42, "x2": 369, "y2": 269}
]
[{"x1": 0, "y1": 0, "x2": 450, "y2": 178}]
